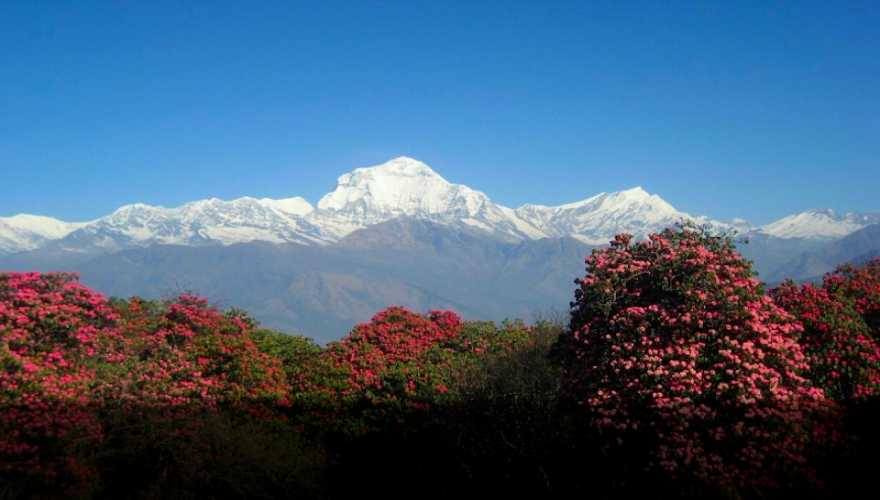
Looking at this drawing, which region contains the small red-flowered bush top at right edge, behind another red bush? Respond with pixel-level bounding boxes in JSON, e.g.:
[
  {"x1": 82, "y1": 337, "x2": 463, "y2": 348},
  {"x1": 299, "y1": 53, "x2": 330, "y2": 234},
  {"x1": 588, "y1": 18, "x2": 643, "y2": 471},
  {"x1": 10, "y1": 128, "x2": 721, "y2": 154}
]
[{"x1": 824, "y1": 257, "x2": 880, "y2": 340}]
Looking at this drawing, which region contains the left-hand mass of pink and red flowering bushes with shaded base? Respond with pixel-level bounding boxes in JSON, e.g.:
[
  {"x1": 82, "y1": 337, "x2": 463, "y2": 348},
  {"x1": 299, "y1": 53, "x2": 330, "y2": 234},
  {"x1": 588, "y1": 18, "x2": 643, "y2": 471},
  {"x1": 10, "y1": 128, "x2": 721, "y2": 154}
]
[{"x1": 0, "y1": 273, "x2": 323, "y2": 498}]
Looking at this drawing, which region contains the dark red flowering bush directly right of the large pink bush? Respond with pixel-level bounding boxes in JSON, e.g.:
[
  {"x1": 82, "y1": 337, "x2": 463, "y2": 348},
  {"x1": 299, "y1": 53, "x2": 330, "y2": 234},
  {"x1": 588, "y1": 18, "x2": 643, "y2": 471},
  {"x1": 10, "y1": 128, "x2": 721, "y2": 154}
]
[{"x1": 772, "y1": 282, "x2": 880, "y2": 402}]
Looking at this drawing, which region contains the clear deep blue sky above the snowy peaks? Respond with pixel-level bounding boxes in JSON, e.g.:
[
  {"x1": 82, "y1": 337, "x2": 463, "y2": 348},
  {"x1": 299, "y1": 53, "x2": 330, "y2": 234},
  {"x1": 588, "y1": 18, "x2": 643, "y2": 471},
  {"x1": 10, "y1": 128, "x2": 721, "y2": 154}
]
[{"x1": 0, "y1": 0, "x2": 880, "y2": 223}]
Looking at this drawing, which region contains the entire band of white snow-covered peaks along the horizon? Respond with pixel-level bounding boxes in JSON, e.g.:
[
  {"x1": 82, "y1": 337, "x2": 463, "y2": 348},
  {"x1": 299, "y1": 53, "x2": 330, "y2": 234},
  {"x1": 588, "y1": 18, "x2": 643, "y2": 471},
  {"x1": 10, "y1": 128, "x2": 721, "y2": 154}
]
[{"x1": 0, "y1": 157, "x2": 880, "y2": 253}]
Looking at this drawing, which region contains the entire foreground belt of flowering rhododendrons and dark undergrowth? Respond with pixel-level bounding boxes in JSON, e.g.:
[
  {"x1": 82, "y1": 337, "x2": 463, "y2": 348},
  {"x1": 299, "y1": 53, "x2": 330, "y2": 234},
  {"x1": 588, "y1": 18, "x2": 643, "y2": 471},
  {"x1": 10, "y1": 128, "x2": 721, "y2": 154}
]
[{"x1": 0, "y1": 228, "x2": 880, "y2": 498}]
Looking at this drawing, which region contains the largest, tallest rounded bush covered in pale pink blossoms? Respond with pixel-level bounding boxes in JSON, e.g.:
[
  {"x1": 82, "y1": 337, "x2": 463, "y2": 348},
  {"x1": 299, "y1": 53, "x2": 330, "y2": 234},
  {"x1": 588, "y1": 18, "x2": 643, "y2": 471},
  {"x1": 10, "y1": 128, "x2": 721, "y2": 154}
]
[{"x1": 563, "y1": 228, "x2": 830, "y2": 488}]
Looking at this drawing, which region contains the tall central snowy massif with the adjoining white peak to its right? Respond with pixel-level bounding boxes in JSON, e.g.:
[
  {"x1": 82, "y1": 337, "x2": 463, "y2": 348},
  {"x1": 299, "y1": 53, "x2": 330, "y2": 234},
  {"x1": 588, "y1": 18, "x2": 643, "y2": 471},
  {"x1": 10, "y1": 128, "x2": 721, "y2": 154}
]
[{"x1": 307, "y1": 157, "x2": 726, "y2": 244}]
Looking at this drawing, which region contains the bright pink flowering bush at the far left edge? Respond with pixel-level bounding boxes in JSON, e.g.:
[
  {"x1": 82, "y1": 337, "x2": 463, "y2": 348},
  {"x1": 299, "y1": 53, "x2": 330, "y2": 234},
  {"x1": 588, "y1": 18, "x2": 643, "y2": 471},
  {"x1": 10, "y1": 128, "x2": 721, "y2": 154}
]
[{"x1": 0, "y1": 273, "x2": 124, "y2": 492}]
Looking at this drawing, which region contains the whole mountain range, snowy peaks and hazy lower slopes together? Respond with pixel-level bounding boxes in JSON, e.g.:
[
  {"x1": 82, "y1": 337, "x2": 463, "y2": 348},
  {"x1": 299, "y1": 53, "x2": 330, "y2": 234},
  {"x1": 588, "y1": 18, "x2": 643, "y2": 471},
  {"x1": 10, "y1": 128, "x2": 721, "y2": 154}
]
[{"x1": 0, "y1": 157, "x2": 880, "y2": 340}]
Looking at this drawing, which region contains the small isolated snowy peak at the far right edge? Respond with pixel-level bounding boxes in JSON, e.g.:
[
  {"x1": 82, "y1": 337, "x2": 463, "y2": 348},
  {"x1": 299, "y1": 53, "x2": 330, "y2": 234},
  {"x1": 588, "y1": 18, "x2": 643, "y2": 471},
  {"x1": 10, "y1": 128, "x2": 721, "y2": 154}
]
[{"x1": 759, "y1": 209, "x2": 880, "y2": 240}]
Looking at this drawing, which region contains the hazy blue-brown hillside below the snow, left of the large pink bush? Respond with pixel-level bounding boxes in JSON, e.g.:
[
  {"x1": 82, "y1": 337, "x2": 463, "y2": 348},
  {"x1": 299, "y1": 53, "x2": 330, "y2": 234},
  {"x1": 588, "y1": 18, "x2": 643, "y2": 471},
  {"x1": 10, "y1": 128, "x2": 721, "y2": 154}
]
[{"x1": 0, "y1": 219, "x2": 591, "y2": 341}]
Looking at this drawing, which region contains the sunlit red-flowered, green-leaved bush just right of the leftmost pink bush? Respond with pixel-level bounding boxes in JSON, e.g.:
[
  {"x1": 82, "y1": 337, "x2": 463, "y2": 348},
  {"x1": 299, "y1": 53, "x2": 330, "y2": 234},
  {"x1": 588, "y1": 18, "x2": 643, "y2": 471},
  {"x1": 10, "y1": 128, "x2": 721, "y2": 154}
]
[{"x1": 105, "y1": 295, "x2": 289, "y2": 409}]
